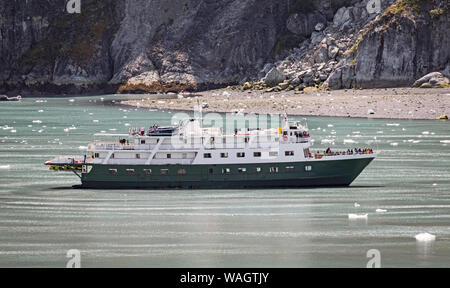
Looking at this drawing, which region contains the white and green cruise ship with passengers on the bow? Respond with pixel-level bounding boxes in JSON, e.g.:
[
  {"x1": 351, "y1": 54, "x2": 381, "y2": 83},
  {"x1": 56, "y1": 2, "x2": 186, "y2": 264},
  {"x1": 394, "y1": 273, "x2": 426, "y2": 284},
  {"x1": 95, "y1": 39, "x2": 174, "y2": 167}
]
[{"x1": 45, "y1": 116, "x2": 376, "y2": 189}]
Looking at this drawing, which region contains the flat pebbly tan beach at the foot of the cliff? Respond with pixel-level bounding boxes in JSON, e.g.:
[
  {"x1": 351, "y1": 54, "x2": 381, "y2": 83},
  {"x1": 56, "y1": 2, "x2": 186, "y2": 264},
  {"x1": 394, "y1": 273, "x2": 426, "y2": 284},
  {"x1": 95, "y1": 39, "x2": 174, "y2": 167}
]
[{"x1": 120, "y1": 88, "x2": 450, "y2": 120}]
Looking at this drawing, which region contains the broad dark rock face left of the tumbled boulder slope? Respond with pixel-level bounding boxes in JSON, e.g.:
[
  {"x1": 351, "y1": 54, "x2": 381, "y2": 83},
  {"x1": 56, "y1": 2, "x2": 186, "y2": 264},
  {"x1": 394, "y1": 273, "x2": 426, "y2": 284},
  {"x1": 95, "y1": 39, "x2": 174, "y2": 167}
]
[{"x1": 0, "y1": 0, "x2": 288, "y2": 93}]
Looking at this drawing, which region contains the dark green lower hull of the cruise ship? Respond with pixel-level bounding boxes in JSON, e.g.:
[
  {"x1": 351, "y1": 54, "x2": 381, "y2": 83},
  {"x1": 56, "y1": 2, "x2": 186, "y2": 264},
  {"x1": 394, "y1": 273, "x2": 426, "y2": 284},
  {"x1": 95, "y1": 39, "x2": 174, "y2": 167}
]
[{"x1": 81, "y1": 158, "x2": 374, "y2": 189}]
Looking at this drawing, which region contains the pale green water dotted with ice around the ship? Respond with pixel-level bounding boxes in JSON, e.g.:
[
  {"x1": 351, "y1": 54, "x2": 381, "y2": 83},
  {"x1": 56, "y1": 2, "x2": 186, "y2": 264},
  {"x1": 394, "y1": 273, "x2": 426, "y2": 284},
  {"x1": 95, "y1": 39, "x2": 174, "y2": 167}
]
[{"x1": 0, "y1": 96, "x2": 450, "y2": 267}]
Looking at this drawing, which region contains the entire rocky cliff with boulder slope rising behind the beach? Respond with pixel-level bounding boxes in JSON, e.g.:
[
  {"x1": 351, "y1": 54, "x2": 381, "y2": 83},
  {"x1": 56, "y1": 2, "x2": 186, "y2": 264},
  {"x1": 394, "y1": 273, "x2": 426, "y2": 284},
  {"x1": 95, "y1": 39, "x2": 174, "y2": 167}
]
[{"x1": 0, "y1": 0, "x2": 450, "y2": 94}]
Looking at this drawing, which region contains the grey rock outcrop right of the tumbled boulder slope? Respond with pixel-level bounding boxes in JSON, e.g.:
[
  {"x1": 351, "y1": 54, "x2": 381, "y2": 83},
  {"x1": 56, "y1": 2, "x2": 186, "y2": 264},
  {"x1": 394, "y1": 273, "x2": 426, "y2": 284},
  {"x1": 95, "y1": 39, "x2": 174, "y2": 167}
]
[{"x1": 328, "y1": 1, "x2": 450, "y2": 89}]
